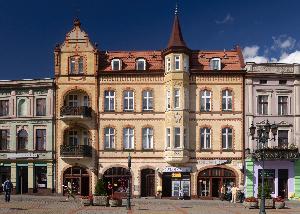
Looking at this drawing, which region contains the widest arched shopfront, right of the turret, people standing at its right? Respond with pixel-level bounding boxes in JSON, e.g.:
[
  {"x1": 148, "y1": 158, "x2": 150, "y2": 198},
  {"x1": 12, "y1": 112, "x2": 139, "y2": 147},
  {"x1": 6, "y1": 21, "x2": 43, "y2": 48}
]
[{"x1": 197, "y1": 167, "x2": 236, "y2": 197}]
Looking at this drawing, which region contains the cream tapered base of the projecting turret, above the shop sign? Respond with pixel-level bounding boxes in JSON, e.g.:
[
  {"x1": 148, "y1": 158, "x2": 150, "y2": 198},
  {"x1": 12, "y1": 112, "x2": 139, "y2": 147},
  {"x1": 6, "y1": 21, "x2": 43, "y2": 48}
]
[{"x1": 164, "y1": 149, "x2": 190, "y2": 164}]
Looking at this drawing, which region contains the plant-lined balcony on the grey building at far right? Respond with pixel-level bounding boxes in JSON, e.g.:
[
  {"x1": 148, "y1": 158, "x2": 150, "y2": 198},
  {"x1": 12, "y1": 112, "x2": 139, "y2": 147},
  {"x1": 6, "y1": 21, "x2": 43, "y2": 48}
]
[{"x1": 252, "y1": 145, "x2": 300, "y2": 160}]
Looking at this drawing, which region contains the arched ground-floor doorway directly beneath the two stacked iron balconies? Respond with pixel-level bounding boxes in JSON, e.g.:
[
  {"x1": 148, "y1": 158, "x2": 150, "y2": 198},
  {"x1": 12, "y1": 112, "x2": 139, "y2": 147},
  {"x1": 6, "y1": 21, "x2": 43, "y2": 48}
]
[{"x1": 63, "y1": 166, "x2": 90, "y2": 196}]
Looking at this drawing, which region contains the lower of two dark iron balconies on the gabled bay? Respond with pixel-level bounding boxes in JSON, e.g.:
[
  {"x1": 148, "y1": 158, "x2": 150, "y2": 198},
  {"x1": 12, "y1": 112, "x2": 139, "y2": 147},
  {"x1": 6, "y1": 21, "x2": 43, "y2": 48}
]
[{"x1": 60, "y1": 145, "x2": 92, "y2": 158}]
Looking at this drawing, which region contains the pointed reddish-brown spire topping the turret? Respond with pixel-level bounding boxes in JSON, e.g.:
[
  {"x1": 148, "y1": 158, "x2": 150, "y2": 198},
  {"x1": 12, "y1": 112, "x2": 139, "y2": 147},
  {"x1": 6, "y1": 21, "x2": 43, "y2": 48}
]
[{"x1": 167, "y1": 2, "x2": 187, "y2": 48}]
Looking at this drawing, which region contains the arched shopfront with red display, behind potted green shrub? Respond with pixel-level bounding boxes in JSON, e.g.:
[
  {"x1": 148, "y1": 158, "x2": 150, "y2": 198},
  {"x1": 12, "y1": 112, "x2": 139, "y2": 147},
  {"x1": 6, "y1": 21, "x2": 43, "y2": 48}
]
[{"x1": 103, "y1": 167, "x2": 132, "y2": 195}]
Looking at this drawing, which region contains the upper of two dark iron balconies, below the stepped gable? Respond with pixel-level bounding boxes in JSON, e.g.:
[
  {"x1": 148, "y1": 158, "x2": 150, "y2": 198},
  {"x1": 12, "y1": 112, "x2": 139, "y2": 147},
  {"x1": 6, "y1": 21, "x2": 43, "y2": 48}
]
[{"x1": 60, "y1": 106, "x2": 92, "y2": 119}]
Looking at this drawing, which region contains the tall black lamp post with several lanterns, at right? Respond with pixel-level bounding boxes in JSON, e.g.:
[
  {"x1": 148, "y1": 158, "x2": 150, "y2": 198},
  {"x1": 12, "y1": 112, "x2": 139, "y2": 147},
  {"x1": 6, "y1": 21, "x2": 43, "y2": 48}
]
[{"x1": 249, "y1": 120, "x2": 278, "y2": 214}]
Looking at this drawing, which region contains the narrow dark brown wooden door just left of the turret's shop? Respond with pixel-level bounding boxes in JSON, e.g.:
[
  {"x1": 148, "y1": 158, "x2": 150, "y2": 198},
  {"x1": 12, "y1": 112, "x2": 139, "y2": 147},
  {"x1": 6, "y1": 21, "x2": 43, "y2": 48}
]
[{"x1": 141, "y1": 169, "x2": 155, "y2": 197}]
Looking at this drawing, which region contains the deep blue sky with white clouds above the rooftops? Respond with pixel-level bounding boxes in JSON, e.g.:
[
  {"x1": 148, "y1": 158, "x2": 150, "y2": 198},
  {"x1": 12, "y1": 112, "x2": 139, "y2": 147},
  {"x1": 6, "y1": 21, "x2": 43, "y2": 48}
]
[{"x1": 0, "y1": 0, "x2": 300, "y2": 79}]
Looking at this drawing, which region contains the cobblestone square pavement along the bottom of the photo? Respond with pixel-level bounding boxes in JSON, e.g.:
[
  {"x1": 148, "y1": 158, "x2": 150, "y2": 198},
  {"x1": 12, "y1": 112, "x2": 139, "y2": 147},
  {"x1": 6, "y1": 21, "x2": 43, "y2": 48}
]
[{"x1": 0, "y1": 195, "x2": 300, "y2": 214}]
